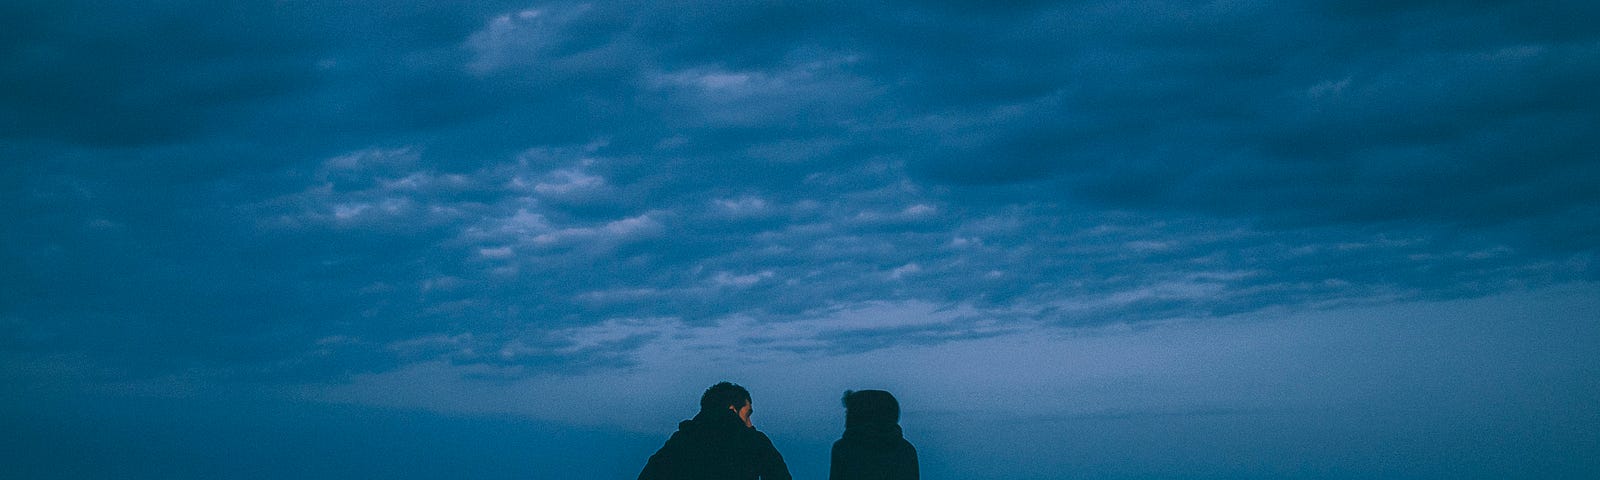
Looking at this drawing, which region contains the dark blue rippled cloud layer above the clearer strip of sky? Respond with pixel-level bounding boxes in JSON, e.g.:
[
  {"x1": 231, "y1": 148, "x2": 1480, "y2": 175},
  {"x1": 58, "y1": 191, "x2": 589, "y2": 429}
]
[{"x1": 0, "y1": 2, "x2": 1600, "y2": 476}]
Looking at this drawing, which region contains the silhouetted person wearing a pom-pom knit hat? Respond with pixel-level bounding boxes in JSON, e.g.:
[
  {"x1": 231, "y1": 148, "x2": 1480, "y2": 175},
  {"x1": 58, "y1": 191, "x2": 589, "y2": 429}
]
[{"x1": 827, "y1": 390, "x2": 920, "y2": 480}]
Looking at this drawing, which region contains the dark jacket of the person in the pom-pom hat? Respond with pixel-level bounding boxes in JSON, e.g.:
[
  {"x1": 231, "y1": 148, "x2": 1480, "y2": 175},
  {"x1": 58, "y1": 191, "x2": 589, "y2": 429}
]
[{"x1": 827, "y1": 424, "x2": 920, "y2": 480}]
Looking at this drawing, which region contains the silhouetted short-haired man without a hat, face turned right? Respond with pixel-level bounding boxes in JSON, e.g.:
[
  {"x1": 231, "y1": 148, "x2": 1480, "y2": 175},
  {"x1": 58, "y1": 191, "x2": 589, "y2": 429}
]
[{"x1": 638, "y1": 382, "x2": 790, "y2": 480}]
